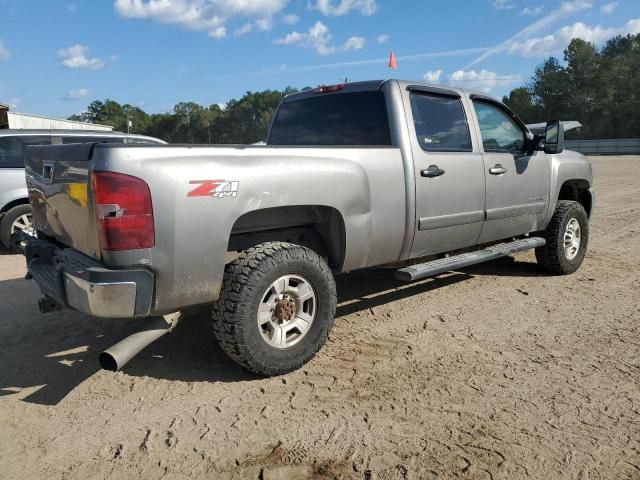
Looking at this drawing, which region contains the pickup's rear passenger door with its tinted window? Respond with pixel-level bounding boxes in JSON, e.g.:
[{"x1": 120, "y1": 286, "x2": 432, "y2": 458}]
[{"x1": 403, "y1": 87, "x2": 485, "y2": 258}]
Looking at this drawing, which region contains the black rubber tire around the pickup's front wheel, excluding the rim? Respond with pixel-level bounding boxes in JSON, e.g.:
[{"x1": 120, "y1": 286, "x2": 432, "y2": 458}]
[{"x1": 536, "y1": 200, "x2": 589, "y2": 275}]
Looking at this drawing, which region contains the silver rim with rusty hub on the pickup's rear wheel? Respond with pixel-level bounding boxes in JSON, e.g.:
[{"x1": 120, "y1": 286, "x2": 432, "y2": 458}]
[{"x1": 257, "y1": 275, "x2": 318, "y2": 350}]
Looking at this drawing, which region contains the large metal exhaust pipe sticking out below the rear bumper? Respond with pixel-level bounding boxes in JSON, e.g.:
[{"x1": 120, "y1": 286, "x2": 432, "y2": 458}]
[{"x1": 99, "y1": 312, "x2": 180, "y2": 372}]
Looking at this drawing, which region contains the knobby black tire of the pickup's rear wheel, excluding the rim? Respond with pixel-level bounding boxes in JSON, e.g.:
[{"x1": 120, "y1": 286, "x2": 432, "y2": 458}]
[{"x1": 212, "y1": 242, "x2": 337, "y2": 376}]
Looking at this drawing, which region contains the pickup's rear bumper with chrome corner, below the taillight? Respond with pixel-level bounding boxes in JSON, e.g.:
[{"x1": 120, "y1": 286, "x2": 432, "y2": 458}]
[{"x1": 24, "y1": 239, "x2": 155, "y2": 318}]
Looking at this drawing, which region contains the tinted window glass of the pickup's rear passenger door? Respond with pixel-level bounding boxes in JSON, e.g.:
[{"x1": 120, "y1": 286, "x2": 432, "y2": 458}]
[{"x1": 411, "y1": 93, "x2": 471, "y2": 152}]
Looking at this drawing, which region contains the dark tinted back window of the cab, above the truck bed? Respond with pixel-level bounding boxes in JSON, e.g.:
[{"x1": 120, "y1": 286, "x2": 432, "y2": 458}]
[{"x1": 268, "y1": 91, "x2": 391, "y2": 146}]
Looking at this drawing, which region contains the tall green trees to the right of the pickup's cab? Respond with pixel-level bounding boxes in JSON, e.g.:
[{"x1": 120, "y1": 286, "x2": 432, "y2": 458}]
[{"x1": 503, "y1": 34, "x2": 640, "y2": 139}]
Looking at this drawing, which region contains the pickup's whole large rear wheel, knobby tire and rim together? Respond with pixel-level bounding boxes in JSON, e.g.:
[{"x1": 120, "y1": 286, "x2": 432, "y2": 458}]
[{"x1": 212, "y1": 242, "x2": 337, "y2": 376}]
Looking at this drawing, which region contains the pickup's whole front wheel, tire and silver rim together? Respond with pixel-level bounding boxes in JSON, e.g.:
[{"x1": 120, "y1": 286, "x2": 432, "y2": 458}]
[{"x1": 536, "y1": 200, "x2": 589, "y2": 275}]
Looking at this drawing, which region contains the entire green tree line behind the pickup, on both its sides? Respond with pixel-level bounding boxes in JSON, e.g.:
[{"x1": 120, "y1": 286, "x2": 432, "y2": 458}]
[{"x1": 70, "y1": 34, "x2": 640, "y2": 144}]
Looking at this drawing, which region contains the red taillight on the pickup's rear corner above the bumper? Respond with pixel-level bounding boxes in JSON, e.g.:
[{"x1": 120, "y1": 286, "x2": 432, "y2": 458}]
[{"x1": 92, "y1": 172, "x2": 155, "y2": 250}]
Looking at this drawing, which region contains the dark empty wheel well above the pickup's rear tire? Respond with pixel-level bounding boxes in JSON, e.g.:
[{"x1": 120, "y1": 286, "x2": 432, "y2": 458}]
[{"x1": 227, "y1": 205, "x2": 346, "y2": 270}]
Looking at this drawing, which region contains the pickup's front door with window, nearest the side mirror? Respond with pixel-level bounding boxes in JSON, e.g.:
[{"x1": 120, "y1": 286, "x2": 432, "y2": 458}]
[{"x1": 473, "y1": 98, "x2": 550, "y2": 243}]
